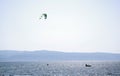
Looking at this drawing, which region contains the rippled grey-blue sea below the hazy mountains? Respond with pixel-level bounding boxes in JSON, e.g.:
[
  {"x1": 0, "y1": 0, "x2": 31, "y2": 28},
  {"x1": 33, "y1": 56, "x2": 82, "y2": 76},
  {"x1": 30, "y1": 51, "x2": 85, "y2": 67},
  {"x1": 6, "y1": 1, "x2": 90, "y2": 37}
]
[{"x1": 0, "y1": 61, "x2": 120, "y2": 76}]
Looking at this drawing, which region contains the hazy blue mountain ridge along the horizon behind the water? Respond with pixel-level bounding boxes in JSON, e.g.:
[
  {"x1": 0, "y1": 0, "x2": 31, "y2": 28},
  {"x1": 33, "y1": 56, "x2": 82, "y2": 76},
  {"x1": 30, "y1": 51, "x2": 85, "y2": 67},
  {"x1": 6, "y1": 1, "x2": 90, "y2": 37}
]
[{"x1": 0, "y1": 50, "x2": 120, "y2": 62}]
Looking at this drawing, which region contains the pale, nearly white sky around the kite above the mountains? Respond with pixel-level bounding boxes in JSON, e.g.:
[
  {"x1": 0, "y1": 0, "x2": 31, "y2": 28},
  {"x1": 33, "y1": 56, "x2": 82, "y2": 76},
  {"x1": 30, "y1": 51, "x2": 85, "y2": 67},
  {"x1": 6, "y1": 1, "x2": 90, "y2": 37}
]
[{"x1": 0, "y1": 0, "x2": 120, "y2": 53}]
